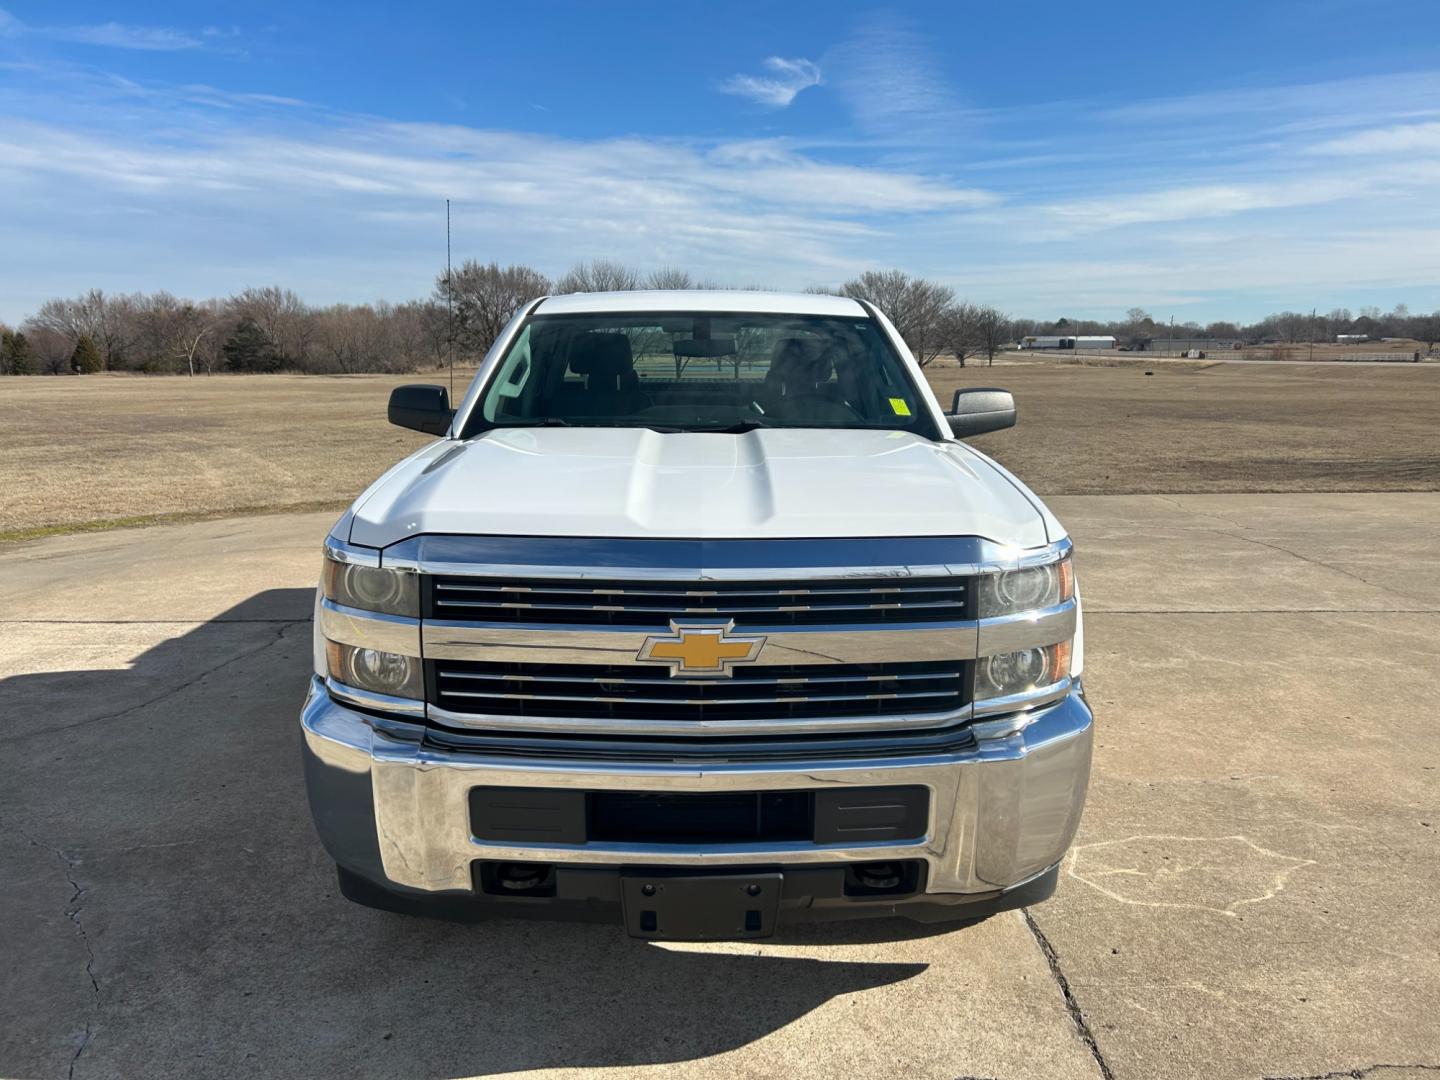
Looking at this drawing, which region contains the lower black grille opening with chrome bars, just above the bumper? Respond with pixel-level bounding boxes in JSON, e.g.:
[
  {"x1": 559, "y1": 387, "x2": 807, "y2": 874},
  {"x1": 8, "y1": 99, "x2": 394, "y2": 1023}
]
[{"x1": 429, "y1": 660, "x2": 968, "y2": 723}]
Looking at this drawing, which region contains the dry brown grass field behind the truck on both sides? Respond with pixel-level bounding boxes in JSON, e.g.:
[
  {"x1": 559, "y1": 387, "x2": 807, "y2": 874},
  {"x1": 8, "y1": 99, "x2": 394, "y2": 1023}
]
[{"x1": 0, "y1": 363, "x2": 1440, "y2": 540}]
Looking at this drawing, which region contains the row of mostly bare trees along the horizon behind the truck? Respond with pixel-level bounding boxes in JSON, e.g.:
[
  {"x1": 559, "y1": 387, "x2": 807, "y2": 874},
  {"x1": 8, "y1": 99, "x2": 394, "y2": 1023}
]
[{"x1": 0, "y1": 259, "x2": 1440, "y2": 376}]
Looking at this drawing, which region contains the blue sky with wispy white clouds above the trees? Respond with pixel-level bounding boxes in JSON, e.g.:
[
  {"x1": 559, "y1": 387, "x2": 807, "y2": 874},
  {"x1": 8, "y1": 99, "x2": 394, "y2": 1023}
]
[{"x1": 0, "y1": 0, "x2": 1440, "y2": 321}]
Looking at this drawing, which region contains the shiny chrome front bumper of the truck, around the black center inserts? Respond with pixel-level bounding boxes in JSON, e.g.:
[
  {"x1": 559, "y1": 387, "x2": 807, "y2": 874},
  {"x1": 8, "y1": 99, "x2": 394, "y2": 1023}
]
[{"x1": 301, "y1": 680, "x2": 1093, "y2": 896}]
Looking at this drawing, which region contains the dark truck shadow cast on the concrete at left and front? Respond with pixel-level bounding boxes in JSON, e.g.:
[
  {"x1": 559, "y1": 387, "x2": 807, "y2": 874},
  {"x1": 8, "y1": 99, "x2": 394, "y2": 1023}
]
[{"x1": 0, "y1": 589, "x2": 940, "y2": 1077}]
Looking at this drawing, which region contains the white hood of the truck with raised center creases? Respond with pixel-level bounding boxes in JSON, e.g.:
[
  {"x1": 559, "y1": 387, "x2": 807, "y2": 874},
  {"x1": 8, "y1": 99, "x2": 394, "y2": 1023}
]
[{"x1": 350, "y1": 428, "x2": 1054, "y2": 547}]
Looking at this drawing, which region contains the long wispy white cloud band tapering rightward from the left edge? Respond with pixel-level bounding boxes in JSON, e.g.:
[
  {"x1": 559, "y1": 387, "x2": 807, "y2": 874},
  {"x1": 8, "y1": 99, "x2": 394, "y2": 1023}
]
[{"x1": 0, "y1": 112, "x2": 998, "y2": 223}]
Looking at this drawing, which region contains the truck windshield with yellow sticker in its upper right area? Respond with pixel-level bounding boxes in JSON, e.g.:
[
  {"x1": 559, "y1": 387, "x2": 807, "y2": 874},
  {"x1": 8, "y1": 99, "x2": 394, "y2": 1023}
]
[{"x1": 464, "y1": 311, "x2": 936, "y2": 438}]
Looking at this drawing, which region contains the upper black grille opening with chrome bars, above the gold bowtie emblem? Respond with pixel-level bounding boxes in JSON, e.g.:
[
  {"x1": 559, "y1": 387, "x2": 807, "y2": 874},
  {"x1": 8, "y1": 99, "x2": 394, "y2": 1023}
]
[{"x1": 426, "y1": 576, "x2": 972, "y2": 626}]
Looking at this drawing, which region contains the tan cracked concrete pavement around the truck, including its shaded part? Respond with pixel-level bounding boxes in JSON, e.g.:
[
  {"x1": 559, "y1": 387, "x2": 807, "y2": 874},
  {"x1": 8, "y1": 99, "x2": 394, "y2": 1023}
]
[{"x1": 0, "y1": 494, "x2": 1440, "y2": 1080}]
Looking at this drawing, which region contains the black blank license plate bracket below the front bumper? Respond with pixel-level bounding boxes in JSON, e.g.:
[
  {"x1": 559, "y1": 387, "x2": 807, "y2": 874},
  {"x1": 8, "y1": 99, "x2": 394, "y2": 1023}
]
[{"x1": 621, "y1": 871, "x2": 783, "y2": 942}]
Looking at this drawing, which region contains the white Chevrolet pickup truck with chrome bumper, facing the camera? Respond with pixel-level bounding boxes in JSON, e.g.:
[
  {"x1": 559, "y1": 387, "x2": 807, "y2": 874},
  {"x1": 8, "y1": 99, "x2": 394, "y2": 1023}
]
[{"x1": 301, "y1": 291, "x2": 1092, "y2": 940}]
